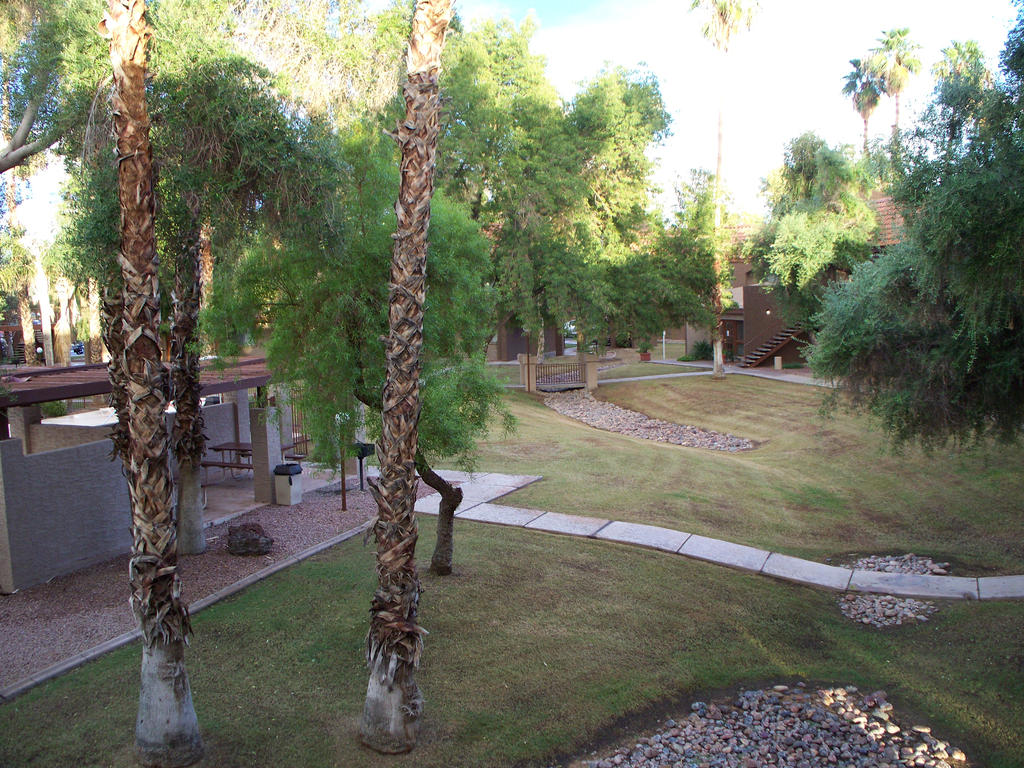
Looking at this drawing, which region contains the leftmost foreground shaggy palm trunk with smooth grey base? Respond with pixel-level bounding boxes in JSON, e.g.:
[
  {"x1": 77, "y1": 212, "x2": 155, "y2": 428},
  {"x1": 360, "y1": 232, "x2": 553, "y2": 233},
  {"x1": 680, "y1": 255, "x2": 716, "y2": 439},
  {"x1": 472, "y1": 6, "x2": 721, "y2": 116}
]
[{"x1": 99, "y1": 0, "x2": 203, "y2": 766}]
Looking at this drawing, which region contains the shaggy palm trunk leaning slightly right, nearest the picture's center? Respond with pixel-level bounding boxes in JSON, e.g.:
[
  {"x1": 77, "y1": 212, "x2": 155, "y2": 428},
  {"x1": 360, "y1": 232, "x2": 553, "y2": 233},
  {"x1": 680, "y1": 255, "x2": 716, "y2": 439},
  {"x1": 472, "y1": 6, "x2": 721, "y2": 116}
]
[{"x1": 359, "y1": 0, "x2": 452, "y2": 753}]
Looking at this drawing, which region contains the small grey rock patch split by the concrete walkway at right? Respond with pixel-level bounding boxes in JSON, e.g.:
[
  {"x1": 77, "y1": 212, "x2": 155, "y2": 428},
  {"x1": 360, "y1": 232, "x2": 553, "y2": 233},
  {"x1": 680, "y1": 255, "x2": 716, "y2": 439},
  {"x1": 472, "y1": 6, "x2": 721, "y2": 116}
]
[{"x1": 838, "y1": 552, "x2": 949, "y2": 629}]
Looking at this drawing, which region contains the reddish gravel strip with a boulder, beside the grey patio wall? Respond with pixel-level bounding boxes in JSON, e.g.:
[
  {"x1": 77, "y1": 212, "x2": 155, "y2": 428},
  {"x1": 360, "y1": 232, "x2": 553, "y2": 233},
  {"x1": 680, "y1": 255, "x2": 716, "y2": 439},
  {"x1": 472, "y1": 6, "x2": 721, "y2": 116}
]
[{"x1": 0, "y1": 478, "x2": 433, "y2": 687}]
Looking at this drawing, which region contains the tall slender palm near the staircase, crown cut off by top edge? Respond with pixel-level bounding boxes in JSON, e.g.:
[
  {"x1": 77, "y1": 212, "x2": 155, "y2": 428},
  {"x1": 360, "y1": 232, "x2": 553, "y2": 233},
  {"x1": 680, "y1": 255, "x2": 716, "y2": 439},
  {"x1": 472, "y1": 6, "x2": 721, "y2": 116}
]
[{"x1": 690, "y1": 0, "x2": 760, "y2": 379}]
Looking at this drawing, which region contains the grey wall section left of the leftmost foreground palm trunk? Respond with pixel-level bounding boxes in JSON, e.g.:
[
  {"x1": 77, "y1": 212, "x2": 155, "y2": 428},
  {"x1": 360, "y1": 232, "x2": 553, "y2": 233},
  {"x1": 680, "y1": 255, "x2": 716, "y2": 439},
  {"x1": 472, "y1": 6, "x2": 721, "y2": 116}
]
[{"x1": 0, "y1": 439, "x2": 131, "y2": 592}]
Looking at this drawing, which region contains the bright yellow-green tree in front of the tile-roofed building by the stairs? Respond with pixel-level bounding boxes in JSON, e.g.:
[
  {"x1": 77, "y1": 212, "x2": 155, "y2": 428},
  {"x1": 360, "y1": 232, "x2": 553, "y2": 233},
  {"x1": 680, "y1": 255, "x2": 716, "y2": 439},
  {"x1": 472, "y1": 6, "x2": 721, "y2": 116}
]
[{"x1": 750, "y1": 133, "x2": 877, "y2": 325}]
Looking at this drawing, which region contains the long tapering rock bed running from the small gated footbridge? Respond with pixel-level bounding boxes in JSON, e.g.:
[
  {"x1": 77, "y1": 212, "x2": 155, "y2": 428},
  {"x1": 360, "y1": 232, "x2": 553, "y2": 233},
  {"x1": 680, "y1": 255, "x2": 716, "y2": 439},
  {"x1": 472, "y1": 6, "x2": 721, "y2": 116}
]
[{"x1": 544, "y1": 390, "x2": 755, "y2": 453}]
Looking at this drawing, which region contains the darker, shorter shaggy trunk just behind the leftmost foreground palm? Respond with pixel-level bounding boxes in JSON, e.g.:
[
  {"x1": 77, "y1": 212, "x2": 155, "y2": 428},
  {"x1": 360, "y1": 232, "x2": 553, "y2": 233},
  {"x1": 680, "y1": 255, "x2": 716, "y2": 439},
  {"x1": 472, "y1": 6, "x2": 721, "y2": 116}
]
[{"x1": 171, "y1": 228, "x2": 206, "y2": 555}]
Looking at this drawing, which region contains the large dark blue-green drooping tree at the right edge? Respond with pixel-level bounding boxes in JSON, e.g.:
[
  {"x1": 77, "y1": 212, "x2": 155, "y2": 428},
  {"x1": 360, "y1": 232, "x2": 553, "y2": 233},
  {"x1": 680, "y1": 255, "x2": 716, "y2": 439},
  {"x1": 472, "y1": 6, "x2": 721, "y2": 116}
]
[{"x1": 811, "y1": 6, "x2": 1024, "y2": 445}]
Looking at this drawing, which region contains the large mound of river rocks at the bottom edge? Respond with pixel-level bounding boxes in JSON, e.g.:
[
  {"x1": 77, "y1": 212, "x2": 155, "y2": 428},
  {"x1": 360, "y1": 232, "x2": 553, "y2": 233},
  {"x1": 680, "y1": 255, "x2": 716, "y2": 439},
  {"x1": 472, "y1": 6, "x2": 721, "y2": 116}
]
[{"x1": 583, "y1": 683, "x2": 967, "y2": 768}]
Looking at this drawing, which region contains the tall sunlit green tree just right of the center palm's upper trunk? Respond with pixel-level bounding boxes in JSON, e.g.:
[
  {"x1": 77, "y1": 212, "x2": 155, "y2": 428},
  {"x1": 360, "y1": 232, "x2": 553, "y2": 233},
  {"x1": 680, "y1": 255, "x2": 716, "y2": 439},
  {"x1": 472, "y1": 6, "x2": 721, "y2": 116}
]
[{"x1": 437, "y1": 19, "x2": 593, "y2": 342}]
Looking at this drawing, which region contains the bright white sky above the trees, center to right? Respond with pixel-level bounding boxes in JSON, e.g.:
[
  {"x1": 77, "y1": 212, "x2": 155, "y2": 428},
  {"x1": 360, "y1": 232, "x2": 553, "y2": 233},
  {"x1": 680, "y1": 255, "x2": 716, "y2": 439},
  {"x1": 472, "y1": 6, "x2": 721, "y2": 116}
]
[{"x1": 440, "y1": 0, "x2": 1016, "y2": 213}]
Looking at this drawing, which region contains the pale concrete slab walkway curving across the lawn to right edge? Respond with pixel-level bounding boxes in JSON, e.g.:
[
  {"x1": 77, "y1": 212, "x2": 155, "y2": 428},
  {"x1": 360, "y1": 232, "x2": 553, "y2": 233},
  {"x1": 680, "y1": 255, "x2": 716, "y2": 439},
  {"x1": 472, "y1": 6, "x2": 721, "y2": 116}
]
[{"x1": 416, "y1": 470, "x2": 1024, "y2": 600}]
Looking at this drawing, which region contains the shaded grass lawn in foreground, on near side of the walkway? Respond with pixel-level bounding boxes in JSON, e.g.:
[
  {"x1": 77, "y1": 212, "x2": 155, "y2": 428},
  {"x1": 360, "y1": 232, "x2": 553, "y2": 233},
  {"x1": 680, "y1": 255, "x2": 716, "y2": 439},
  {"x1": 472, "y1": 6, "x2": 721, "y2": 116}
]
[{"x1": 0, "y1": 518, "x2": 1024, "y2": 768}]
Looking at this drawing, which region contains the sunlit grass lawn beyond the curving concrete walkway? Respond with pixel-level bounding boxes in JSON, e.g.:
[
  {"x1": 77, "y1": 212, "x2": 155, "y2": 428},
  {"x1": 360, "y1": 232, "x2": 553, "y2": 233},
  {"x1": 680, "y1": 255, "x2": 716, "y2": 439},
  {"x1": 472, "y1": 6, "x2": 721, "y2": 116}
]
[{"x1": 480, "y1": 376, "x2": 1024, "y2": 575}]
